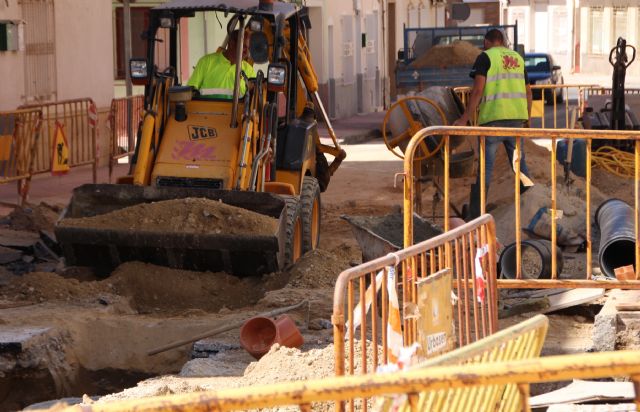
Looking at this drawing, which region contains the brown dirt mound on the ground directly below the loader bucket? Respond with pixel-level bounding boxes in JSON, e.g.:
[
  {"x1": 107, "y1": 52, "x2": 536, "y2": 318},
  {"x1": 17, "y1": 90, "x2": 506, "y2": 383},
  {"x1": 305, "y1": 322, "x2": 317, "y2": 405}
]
[{"x1": 107, "y1": 262, "x2": 263, "y2": 313}]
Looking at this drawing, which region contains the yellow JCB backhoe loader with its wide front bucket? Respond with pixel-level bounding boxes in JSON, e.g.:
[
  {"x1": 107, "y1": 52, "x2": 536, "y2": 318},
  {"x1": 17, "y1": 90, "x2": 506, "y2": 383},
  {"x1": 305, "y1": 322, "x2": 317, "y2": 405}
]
[{"x1": 56, "y1": 0, "x2": 346, "y2": 276}]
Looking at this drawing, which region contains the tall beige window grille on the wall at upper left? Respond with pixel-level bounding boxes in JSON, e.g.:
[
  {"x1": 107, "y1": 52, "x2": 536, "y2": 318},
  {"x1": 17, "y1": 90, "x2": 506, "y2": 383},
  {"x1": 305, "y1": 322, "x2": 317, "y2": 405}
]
[{"x1": 21, "y1": 0, "x2": 56, "y2": 102}]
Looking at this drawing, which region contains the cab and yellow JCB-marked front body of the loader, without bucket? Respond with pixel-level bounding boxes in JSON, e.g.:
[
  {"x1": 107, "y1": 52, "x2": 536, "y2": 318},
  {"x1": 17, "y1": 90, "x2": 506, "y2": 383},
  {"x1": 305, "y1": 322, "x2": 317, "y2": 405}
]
[{"x1": 131, "y1": 0, "x2": 326, "y2": 195}]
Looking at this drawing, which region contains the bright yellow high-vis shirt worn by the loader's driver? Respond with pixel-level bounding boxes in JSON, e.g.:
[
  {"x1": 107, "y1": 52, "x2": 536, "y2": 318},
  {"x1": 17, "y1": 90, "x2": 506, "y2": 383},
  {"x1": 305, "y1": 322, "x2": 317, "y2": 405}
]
[{"x1": 187, "y1": 52, "x2": 256, "y2": 99}]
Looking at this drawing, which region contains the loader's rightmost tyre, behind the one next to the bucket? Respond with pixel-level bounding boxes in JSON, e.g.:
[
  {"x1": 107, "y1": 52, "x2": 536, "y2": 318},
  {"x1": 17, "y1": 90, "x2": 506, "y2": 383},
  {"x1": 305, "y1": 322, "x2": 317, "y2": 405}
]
[{"x1": 300, "y1": 176, "x2": 321, "y2": 253}]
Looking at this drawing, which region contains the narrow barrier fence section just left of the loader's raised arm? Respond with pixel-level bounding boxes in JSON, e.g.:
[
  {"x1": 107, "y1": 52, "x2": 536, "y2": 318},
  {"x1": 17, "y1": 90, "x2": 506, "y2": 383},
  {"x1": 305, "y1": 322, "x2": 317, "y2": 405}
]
[{"x1": 109, "y1": 95, "x2": 144, "y2": 182}]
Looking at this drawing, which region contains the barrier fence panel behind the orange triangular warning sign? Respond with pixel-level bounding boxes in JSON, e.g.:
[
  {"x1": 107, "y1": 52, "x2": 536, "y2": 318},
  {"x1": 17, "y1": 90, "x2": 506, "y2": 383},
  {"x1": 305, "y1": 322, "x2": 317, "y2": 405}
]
[{"x1": 20, "y1": 98, "x2": 98, "y2": 183}]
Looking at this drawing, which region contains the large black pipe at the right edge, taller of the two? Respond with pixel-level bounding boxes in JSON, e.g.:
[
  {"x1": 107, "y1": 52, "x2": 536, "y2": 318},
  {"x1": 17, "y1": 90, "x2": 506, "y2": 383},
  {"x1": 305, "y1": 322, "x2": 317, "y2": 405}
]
[{"x1": 596, "y1": 199, "x2": 636, "y2": 277}]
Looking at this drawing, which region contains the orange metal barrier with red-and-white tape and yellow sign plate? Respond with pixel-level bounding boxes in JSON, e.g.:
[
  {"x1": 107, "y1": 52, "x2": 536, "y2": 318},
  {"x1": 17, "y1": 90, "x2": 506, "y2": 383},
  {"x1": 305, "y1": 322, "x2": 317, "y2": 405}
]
[{"x1": 332, "y1": 215, "x2": 498, "y2": 406}]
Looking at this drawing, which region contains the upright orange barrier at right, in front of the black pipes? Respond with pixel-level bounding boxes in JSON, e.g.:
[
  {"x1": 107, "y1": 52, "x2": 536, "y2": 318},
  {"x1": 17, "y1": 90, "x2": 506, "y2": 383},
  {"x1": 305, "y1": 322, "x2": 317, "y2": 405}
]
[{"x1": 404, "y1": 126, "x2": 640, "y2": 289}]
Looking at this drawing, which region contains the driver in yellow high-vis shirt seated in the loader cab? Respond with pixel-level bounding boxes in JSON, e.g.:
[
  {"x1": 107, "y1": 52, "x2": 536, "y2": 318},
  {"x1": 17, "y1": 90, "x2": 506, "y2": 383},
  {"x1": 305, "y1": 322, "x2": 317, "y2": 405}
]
[{"x1": 187, "y1": 30, "x2": 256, "y2": 99}]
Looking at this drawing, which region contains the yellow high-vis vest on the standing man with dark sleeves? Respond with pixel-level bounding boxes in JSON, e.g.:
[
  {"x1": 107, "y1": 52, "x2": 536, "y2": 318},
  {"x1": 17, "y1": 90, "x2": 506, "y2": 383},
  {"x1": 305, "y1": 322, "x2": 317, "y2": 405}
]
[{"x1": 478, "y1": 47, "x2": 529, "y2": 125}]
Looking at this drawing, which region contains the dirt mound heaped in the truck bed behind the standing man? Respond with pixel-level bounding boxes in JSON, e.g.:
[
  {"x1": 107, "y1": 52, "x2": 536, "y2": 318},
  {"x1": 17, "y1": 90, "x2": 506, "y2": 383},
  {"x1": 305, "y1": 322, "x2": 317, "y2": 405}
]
[{"x1": 409, "y1": 41, "x2": 482, "y2": 69}]
